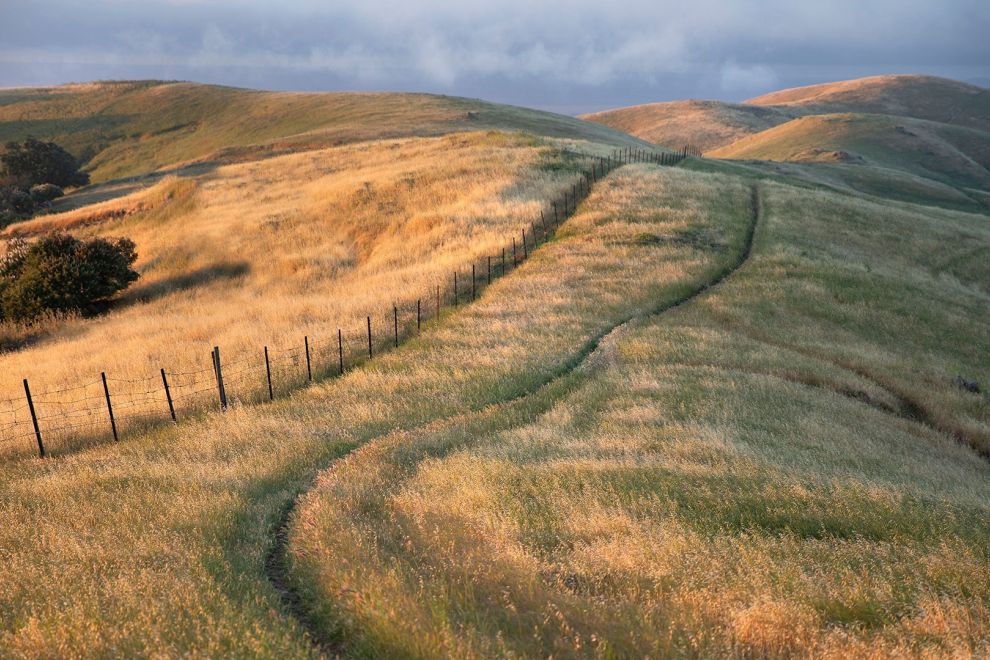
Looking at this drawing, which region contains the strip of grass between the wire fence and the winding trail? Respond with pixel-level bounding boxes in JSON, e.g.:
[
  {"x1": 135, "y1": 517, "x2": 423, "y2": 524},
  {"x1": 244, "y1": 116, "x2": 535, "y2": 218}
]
[{"x1": 0, "y1": 166, "x2": 749, "y2": 657}]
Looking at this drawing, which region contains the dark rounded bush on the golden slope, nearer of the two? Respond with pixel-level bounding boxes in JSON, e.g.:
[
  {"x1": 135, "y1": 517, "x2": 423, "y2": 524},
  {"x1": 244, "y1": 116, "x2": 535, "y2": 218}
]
[{"x1": 0, "y1": 233, "x2": 138, "y2": 321}]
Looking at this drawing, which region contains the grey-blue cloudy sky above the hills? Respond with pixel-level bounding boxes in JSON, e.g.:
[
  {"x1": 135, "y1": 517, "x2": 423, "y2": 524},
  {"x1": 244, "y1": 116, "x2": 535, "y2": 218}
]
[{"x1": 0, "y1": 0, "x2": 990, "y2": 113}]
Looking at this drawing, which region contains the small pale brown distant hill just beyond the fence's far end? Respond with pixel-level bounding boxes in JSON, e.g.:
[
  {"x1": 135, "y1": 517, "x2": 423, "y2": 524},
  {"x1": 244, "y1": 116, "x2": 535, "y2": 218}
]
[{"x1": 581, "y1": 101, "x2": 792, "y2": 151}]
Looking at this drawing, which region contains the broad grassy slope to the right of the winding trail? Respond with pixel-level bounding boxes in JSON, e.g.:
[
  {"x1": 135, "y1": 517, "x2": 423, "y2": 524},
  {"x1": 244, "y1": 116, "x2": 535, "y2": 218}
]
[{"x1": 289, "y1": 164, "x2": 990, "y2": 657}]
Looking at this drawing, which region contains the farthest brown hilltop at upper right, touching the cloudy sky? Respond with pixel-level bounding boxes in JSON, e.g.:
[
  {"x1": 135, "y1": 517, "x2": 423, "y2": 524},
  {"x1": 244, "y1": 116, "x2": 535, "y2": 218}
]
[{"x1": 746, "y1": 75, "x2": 990, "y2": 131}]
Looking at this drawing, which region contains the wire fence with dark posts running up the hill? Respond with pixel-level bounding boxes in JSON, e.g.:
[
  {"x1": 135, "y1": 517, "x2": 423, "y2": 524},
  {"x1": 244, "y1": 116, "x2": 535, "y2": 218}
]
[{"x1": 0, "y1": 147, "x2": 689, "y2": 458}]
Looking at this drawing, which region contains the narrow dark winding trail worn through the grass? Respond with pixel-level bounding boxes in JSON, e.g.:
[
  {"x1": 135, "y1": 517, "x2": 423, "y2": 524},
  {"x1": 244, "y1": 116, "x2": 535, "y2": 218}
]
[{"x1": 264, "y1": 178, "x2": 762, "y2": 657}]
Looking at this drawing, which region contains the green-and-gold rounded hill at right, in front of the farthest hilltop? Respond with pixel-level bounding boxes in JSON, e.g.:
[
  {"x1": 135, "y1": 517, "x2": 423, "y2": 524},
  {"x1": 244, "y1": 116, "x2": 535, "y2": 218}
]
[{"x1": 708, "y1": 114, "x2": 990, "y2": 190}]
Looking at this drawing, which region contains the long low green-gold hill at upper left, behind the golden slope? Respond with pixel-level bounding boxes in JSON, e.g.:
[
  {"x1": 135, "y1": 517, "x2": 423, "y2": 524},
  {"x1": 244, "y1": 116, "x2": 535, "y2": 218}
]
[{"x1": 0, "y1": 81, "x2": 642, "y2": 182}]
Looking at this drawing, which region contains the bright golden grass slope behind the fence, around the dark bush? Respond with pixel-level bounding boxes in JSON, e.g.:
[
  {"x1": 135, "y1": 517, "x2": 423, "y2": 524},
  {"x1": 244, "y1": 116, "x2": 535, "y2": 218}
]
[{"x1": 0, "y1": 133, "x2": 607, "y2": 454}]
